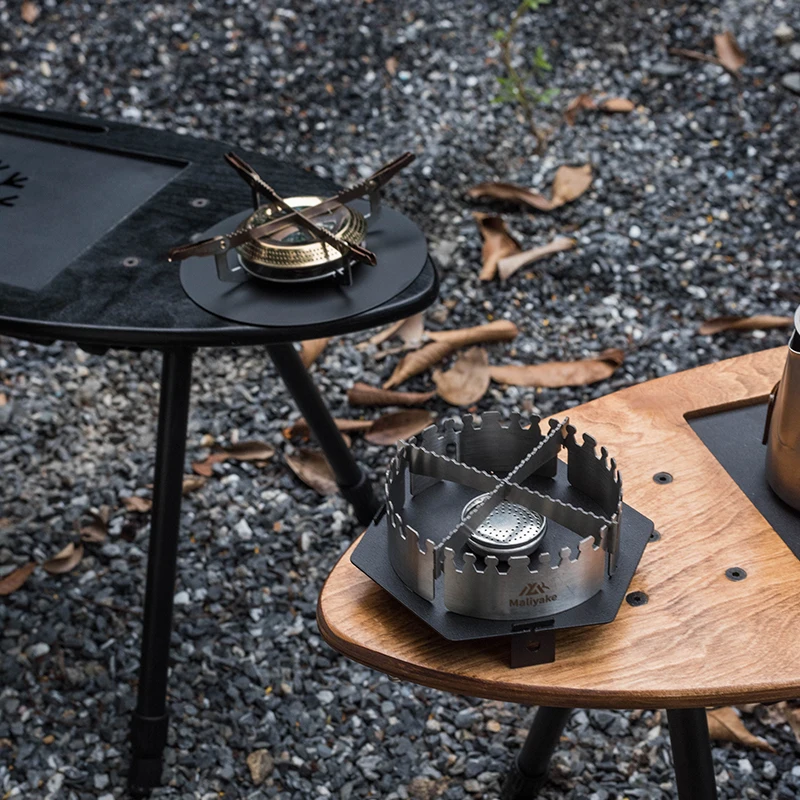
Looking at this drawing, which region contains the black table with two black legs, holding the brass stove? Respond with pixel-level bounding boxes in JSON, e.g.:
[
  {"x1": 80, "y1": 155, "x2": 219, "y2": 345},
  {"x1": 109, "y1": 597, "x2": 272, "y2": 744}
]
[{"x1": 0, "y1": 106, "x2": 438, "y2": 792}]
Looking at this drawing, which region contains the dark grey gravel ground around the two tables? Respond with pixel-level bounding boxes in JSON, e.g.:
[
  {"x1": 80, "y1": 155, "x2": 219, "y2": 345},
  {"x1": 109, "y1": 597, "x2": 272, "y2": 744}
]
[{"x1": 0, "y1": 0, "x2": 800, "y2": 800}]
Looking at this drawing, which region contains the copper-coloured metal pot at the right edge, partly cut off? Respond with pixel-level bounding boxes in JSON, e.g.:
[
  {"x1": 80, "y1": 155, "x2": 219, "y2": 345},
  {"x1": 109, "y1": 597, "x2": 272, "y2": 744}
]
[{"x1": 764, "y1": 307, "x2": 800, "y2": 510}]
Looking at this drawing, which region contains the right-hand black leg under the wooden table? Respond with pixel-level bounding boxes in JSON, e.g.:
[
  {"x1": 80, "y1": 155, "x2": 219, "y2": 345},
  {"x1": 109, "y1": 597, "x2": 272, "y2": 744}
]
[{"x1": 667, "y1": 708, "x2": 717, "y2": 800}]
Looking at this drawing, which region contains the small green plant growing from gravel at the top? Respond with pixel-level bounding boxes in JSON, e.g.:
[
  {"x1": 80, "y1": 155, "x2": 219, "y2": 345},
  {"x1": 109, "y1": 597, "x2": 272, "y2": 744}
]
[{"x1": 493, "y1": 0, "x2": 558, "y2": 153}]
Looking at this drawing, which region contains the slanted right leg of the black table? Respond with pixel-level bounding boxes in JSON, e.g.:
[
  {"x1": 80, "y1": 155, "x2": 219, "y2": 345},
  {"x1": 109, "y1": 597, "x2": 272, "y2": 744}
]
[{"x1": 267, "y1": 344, "x2": 380, "y2": 525}]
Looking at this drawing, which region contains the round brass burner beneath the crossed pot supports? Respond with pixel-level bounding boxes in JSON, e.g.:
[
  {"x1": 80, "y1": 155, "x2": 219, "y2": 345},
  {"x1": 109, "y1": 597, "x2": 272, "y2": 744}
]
[{"x1": 236, "y1": 196, "x2": 367, "y2": 282}]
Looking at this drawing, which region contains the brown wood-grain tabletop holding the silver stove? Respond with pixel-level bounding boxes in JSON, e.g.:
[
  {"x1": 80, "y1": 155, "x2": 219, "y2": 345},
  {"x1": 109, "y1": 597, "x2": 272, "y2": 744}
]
[{"x1": 317, "y1": 348, "x2": 800, "y2": 708}]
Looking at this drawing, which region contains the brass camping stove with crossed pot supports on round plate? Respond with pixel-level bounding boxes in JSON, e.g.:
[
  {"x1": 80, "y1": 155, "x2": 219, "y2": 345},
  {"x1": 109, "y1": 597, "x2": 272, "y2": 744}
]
[{"x1": 169, "y1": 153, "x2": 414, "y2": 286}]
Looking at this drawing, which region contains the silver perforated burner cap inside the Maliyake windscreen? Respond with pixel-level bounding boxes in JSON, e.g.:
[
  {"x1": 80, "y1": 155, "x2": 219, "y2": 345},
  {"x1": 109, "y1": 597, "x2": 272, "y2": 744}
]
[{"x1": 461, "y1": 494, "x2": 547, "y2": 559}]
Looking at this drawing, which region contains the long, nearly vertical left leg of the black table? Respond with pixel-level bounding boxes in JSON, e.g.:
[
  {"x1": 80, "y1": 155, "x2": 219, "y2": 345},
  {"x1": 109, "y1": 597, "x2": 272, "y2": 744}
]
[{"x1": 129, "y1": 348, "x2": 192, "y2": 793}]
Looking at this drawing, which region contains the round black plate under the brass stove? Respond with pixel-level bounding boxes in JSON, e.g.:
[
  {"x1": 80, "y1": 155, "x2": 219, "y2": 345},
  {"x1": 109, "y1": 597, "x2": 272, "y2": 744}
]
[{"x1": 181, "y1": 201, "x2": 428, "y2": 327}]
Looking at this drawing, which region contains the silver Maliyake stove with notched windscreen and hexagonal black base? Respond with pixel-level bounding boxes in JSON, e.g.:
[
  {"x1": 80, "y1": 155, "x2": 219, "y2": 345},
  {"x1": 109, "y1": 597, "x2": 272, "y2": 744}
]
[{"x1": 352, "y1": 412, "x2": 653, "y2": 666}]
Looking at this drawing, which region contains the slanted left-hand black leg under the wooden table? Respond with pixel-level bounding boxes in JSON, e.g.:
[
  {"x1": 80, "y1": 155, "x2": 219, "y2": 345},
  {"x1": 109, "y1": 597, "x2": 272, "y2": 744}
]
[{"x1": 502, "y1": 706, "x2": 572, "y2": 800}]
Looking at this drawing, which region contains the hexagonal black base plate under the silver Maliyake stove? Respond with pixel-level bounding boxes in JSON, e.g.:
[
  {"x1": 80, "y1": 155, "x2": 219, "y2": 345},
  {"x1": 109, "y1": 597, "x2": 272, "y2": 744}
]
[{"x1": 350, "y1": 461, "x2": 653, "y2": 641}]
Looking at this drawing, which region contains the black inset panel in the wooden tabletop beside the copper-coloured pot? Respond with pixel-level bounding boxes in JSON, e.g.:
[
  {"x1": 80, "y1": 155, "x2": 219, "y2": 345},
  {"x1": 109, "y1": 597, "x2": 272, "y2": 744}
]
[{"x1": 689, "y1": 403, "x2": 800, "y2": 558}]
